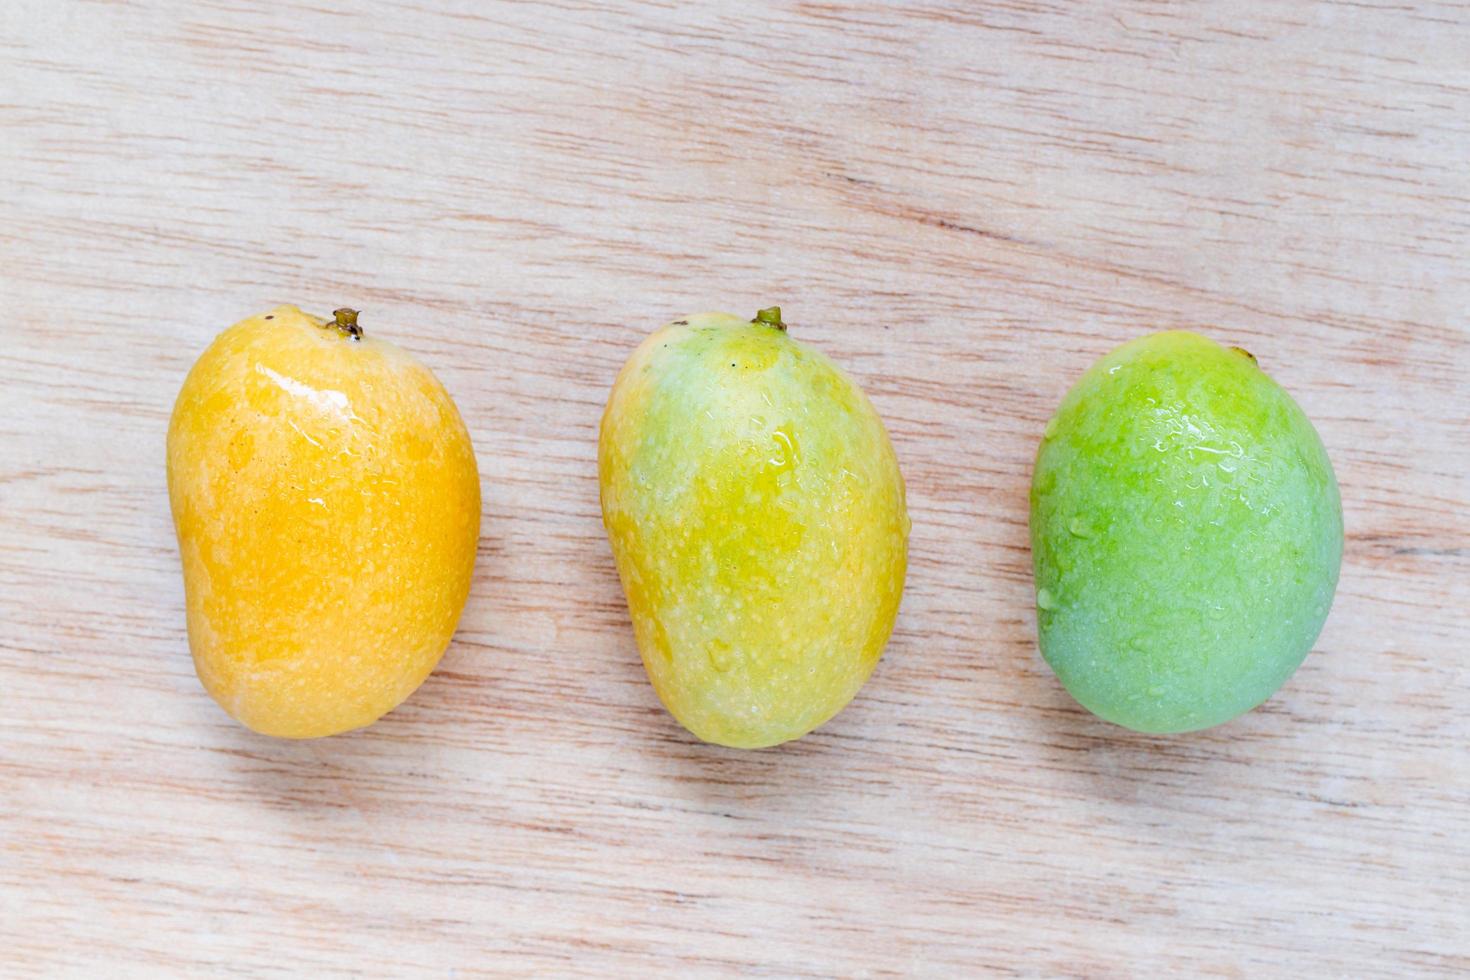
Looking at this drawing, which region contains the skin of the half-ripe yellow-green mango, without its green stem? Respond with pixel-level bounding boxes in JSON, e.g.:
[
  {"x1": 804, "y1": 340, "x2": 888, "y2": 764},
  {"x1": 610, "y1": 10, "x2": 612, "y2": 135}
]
[{"x1": 598, "y1": 313, "x2": 908, "y2": 748}]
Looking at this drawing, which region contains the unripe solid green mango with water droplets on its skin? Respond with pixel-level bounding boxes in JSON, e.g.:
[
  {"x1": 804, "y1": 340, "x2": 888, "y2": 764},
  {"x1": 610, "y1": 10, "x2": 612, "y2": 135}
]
[{"x1": 1030, "y1": 332, "x2": 1342, "y2": 733}]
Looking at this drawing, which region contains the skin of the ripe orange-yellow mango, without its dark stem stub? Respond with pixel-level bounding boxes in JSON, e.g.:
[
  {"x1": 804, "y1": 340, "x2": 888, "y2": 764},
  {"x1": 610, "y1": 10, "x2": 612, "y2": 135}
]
[{"x1": 168, "y1": 306, "x2": 479, "y2": 739}]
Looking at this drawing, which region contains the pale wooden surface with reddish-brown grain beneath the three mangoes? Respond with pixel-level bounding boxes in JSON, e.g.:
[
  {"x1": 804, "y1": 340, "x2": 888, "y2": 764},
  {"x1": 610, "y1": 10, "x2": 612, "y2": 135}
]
[{"x1": 0, "y1": 0, "x2": 1470, "y2": 977}]
